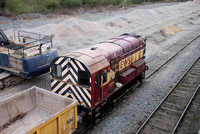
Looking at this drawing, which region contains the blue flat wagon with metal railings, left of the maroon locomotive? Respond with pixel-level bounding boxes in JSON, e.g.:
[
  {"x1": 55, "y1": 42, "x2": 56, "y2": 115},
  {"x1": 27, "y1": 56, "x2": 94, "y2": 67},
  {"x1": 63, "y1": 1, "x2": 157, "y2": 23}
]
[{"x1": 0, "y1": 30, "x2": 58, "y2": 89}]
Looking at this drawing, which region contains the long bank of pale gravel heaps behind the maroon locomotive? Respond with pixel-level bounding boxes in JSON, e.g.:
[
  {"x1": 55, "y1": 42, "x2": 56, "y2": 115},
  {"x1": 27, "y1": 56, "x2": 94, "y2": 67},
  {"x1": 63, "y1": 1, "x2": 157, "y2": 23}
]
[{"x1": 0, "y1": 2, "x2": 199, "y2": 55}]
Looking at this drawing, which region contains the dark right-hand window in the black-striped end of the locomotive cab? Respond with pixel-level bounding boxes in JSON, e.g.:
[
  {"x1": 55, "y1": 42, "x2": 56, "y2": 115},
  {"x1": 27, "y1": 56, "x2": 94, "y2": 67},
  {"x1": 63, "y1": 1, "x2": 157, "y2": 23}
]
[{"x1": 78, "y1": 70, "x2": 89, "y2": 86}]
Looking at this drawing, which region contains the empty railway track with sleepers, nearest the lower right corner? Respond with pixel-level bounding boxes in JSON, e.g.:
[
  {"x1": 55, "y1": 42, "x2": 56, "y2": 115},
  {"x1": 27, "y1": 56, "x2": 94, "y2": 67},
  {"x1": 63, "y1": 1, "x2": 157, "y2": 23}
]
[{"x1": 136, "y1": 58, "x2": 200, "y2": 134}]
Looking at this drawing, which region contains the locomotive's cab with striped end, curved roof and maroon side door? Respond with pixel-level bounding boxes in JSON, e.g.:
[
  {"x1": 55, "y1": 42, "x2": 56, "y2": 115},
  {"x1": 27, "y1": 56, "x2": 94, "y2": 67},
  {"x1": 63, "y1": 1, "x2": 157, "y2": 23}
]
[{"x1": 51, "y1": 50, "x2": 110, "y2": 109}]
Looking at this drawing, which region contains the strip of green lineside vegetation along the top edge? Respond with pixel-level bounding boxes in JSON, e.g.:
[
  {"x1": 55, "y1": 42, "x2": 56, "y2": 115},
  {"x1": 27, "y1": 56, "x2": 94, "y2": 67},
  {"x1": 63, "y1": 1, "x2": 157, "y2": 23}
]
[{"x1": 0, "y1": 0, "x2": 188, "y2": 14}]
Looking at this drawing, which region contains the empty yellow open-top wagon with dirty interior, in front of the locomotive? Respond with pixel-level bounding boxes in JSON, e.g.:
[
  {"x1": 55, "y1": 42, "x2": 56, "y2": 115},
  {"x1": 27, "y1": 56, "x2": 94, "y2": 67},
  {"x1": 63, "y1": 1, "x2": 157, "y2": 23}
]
[{"x1": 0, "y1": 87, "x2": 77, "y2": 134}]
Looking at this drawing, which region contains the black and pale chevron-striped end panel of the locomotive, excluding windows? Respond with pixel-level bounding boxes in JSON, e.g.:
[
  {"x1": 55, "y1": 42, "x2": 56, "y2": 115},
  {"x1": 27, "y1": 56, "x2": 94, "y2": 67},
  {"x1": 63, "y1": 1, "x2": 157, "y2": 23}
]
[{"x1": 51, "y1": 57, "x2": 91, "y2": 108}]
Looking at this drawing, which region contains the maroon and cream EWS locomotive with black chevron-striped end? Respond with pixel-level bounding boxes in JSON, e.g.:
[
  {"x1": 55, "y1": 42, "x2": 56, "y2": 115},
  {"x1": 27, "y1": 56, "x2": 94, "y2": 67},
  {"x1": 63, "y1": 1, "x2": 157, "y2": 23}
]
[{"x1": 50, "y1": 33, "x2": 146, "y2": 122}]
